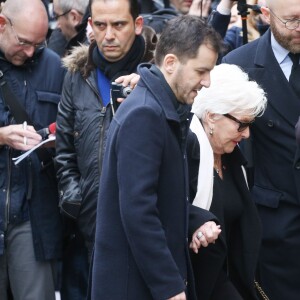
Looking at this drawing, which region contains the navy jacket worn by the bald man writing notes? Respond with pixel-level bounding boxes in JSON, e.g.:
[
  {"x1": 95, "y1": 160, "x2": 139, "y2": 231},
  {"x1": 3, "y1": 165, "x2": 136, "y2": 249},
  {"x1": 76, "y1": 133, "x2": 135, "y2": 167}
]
[{"x1": 0, "y1": 49, "x2": 65, "y2": 260}]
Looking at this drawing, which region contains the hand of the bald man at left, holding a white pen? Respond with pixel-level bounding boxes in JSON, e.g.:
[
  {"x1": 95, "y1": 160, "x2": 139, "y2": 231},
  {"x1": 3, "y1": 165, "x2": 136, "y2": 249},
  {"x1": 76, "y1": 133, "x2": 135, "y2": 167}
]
[{"x1": 0, "y1": 124, "x2": 42, "y2": 151}]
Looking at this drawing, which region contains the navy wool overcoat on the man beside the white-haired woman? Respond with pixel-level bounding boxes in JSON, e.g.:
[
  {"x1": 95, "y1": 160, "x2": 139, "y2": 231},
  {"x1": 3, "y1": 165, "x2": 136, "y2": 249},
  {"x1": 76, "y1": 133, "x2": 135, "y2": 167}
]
[{"x1": 92, "y1": 65, "x2": 213, "y2": 300}]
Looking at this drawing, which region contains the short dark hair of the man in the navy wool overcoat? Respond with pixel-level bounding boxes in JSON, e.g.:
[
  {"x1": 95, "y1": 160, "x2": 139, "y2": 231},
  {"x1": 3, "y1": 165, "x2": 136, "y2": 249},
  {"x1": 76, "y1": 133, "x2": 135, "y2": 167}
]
[{"x1": 154, "y1": 15, "x2": 223, "y2": 66}]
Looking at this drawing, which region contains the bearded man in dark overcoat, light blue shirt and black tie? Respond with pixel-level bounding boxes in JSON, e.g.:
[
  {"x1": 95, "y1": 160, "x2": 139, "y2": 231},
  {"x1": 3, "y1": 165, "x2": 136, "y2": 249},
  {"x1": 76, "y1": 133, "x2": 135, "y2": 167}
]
[{"x1": 223, "y1": 0, "x2": 300, "y2": 300}]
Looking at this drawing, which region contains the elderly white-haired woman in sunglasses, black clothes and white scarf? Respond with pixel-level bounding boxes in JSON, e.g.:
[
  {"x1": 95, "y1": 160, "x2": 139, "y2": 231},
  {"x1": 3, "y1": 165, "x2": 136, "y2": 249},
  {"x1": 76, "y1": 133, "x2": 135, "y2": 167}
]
[{"x1": 188, "y1": 64, "x2": 266, "y2": 300}]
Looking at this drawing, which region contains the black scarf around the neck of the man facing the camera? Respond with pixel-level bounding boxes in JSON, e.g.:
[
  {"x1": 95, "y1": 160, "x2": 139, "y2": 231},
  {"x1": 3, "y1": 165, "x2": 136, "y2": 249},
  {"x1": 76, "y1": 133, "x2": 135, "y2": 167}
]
[{"x1": 93, "y1": 35, "x2": 145, "y2": 81}]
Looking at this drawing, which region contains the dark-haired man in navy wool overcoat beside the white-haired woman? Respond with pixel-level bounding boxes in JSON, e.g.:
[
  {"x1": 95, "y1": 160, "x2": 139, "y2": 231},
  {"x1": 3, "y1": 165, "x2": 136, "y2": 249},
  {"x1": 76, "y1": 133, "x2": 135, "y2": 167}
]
[{"x1": 92, "y1": 16, "x2": 221, "y2": 300}]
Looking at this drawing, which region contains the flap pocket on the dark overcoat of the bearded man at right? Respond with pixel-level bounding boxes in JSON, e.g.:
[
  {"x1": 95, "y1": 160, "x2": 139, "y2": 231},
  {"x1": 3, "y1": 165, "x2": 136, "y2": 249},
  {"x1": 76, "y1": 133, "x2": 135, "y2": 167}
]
[{"x1": 251, "y1": 185, "x2": 283, "y2": 208}]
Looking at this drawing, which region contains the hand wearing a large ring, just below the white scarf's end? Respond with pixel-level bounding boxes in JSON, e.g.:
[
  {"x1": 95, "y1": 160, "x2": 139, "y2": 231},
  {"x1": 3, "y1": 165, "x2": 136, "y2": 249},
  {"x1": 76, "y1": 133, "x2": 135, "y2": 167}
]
[{"x1": 190, "y1": 221, "x2": 221, "y2": 253}]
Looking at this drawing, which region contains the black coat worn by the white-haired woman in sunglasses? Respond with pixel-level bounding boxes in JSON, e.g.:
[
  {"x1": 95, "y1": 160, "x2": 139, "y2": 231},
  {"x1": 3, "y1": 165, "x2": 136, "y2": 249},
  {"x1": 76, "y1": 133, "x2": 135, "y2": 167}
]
[{"x1": 188, "y1": 135, "x2": 261, "y2": 300}]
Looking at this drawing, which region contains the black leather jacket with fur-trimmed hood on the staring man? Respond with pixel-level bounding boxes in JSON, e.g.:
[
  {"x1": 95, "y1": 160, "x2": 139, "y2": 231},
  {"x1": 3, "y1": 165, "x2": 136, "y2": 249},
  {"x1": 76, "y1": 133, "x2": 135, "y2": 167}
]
[{"x1": 55, "y1": 27, "x2": 156, "y2": 243}]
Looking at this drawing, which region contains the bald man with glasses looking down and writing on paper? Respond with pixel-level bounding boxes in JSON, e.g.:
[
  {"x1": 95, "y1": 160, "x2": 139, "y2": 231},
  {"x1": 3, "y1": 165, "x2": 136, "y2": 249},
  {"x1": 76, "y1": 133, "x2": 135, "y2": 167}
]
[{"x1": 0, "y1": 0, "x2": 65, "y2": 300}]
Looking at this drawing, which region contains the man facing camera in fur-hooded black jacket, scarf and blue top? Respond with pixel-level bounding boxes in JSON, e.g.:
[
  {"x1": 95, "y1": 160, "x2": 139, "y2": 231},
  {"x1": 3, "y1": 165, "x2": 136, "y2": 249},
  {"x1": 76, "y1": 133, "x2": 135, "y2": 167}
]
[{"x1": 56, "y1": 0, "x2": 156, "y2": 298}]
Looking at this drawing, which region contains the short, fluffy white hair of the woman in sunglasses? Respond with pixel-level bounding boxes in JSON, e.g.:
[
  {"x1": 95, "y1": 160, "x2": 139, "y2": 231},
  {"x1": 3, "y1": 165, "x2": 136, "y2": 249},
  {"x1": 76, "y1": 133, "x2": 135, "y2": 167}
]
[{"x1": 192, "y1": 64, "x2": 267, "y2": 119}]
